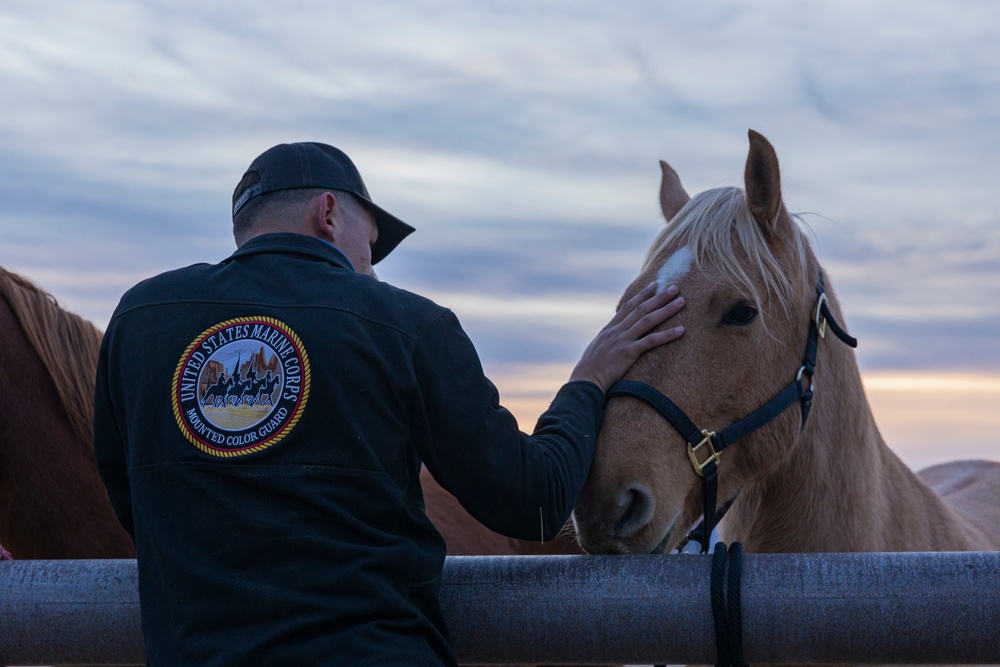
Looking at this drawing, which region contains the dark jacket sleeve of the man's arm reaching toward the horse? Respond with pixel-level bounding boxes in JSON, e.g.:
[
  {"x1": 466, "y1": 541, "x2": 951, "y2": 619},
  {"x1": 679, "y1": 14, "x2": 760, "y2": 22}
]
[{"x1": 406, "y1": 311, "x2": 605, "y2": 540}]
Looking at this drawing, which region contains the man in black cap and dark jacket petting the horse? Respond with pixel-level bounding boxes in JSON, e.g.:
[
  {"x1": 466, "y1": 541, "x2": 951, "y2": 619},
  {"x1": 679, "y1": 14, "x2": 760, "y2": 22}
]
[{"x1": 95, "y1": 143, "x2": 682, "y2": 667}]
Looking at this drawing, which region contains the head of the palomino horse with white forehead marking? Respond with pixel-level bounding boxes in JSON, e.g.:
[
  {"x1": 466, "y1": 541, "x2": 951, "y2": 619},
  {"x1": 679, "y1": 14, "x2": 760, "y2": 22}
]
[{"x1": 574, "y1": 130, "x2": 852, "y2": 553}]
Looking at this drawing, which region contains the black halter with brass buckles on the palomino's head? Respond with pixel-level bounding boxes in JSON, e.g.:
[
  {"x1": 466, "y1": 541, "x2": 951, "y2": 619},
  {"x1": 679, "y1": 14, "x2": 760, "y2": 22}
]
[{"x1": 608, "y1": 272, "x2": 858, "y2": 553}]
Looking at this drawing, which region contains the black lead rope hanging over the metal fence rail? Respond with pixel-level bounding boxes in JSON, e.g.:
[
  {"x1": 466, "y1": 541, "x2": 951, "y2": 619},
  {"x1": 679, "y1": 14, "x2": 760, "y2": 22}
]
[{"x1": 655, "y1": 542, "x2": 748, "y2": 667}]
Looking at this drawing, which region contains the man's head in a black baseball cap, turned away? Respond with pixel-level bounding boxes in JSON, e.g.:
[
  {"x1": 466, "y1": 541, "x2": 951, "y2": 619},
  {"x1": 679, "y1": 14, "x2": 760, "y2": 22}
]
[{"x1": 233, "y1": 142, "x2": 413, "y2": 271}]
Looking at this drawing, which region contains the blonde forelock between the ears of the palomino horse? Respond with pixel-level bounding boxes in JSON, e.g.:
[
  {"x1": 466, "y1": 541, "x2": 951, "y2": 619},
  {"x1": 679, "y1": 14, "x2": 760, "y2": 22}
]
[{"x1": 642, "y1": 187, "x2": 808, "y2": 320}]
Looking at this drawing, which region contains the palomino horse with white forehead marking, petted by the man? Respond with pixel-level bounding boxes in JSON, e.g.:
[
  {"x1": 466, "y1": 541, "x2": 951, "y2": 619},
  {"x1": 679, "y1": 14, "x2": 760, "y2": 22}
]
[{"x1": 574, "y1": 131, "x2": 1000, "y2": 553}]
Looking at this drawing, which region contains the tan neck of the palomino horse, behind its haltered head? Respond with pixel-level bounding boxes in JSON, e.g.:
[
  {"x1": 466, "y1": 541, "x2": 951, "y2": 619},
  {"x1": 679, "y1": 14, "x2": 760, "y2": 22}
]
[{"x1": 723, "y1": 318, "x2": 969, "y2": 552}]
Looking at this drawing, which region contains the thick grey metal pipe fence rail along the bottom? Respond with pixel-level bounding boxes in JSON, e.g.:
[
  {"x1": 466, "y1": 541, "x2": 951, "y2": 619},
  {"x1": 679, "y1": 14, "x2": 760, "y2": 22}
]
[{"x1": 0, "y1": 553, "x2": 1000, "y2": 665}]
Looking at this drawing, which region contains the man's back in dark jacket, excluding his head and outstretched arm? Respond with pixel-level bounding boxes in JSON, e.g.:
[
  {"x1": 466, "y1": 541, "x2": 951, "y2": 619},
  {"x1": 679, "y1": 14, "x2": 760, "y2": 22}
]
[{"x1": 98, "y1": 235, "x2": 450, "y2": 665}]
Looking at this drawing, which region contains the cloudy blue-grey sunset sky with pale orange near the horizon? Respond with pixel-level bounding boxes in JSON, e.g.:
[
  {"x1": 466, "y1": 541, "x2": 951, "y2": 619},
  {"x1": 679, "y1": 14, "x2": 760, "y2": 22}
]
[{"x1": 0, "y1": 0, "x2": 1000, "y2": 467}]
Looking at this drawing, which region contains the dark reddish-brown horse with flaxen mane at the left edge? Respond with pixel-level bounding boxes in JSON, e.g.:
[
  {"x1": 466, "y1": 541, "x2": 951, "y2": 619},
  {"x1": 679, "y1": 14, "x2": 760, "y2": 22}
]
[{"x1": 0, "y1": 268, "x2": 135, "y2": 559}]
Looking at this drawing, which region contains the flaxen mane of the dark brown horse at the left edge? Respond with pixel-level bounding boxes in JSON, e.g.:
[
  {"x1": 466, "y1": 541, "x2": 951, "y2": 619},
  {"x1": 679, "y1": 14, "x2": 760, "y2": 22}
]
[{"x1": 0, "y1": 267, "x2": 102, "y2": 445}]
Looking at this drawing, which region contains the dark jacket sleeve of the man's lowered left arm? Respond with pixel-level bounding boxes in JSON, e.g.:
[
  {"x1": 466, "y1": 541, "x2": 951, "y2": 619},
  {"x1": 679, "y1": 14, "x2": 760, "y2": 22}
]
[{"x1": 94, "y1": 327, "x2": 135, "y2": 541}]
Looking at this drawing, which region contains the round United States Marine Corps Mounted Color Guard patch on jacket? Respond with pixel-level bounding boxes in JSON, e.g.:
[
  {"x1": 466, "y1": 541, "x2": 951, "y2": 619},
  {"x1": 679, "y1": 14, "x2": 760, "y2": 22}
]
[{"x1": 172, "y1": 317, "x2": 310, "y2": 457}]
